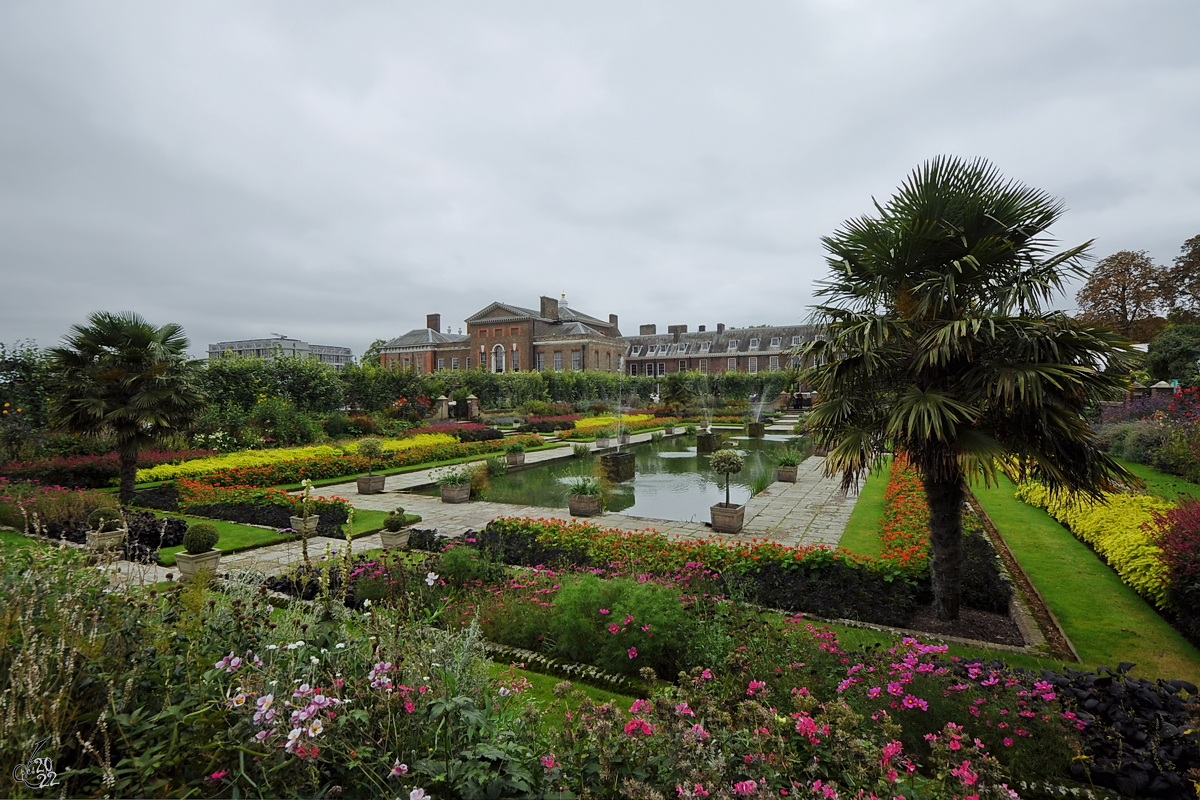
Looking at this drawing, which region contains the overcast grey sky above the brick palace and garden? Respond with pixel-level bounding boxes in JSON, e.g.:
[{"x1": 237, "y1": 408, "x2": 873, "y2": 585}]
[{"x1": 0, "y1": 0, "x2": 1200, "y2": 355}]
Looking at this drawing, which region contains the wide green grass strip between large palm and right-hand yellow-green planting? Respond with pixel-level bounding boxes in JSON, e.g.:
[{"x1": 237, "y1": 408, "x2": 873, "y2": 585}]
[{"x1": 973, "y1": 477, "x2": 1200, "y2": 682}]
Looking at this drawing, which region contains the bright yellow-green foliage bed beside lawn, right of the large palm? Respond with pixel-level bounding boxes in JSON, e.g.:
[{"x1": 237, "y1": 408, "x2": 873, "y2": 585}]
[{"x1": 1016, "y1": 483, "x2": 1175, "y2": 608}]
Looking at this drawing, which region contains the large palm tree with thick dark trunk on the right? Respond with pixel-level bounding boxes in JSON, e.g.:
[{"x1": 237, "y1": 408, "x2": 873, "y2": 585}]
[{"x1": 802, "y1": 157, "x2": 1136, "y2": 619}]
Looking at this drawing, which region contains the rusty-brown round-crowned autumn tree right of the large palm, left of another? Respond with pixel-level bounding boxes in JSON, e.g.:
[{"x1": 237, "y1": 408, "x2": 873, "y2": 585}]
[{"x1": 1075, "y1": 249, "x2": 1170, "y2": 342}]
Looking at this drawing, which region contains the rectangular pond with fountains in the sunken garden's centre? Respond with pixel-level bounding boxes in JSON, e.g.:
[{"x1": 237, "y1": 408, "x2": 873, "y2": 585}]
[{"x1": 422, "y1": 434, "x2": 811, "y2": 522}]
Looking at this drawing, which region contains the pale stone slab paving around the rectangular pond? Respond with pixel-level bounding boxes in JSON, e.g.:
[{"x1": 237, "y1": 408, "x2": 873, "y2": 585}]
[{"x1": 105, "y1": 417, "x2": 857, "y2": 582}]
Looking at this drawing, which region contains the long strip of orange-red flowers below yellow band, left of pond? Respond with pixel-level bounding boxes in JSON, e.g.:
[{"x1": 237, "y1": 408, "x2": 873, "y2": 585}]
[{"x1": 154, "y1": 435, "x2": 545, "y2": 486}]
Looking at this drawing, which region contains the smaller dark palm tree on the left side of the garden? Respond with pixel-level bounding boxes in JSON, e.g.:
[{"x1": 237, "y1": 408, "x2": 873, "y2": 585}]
[{"x1": 50, "y1": 312, "x2": 203, "y2": 503}]
